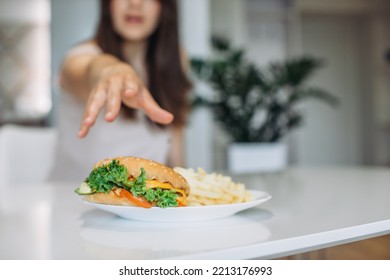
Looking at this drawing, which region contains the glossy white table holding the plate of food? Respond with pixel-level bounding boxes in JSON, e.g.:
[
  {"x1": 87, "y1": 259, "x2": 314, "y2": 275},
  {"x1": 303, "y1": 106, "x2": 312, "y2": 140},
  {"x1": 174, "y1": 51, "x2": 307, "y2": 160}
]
[{"x1": 0, "y1": 167, "x2": 390, "y2": 259}]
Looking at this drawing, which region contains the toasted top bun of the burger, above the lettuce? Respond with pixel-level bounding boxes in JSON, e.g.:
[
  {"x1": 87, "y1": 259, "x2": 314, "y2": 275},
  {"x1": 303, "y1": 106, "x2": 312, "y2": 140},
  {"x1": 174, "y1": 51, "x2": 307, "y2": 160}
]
[{"x1": 94, "y1": 156, "x2": 190, "y2": 196}]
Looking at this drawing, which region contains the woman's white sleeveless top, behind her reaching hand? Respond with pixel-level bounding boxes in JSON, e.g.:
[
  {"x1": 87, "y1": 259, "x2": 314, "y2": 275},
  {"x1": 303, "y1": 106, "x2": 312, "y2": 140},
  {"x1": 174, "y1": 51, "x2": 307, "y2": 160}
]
[{"x1": 50, "y1": 44, "x2": 172, "y2": 182}]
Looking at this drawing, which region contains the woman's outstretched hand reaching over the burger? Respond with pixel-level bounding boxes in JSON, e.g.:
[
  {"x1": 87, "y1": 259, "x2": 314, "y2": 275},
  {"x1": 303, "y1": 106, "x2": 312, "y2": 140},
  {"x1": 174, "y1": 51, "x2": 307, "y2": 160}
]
[{"x1": 78, "y1": 63, "x2": 173, "y2": 138}]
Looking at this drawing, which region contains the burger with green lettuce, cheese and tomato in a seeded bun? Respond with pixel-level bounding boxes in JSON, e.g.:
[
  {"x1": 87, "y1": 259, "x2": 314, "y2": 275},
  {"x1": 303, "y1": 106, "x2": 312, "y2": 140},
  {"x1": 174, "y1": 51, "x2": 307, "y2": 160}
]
[{"x1": 75, "y1": 157, "x2": 190, "y2": 208}]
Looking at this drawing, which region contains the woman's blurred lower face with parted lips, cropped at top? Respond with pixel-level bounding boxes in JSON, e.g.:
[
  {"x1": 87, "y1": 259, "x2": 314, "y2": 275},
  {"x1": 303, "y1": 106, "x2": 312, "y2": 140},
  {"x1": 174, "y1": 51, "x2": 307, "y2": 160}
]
[{"x1": 111, "y1": 0, "x2": 161, "y2": 42}]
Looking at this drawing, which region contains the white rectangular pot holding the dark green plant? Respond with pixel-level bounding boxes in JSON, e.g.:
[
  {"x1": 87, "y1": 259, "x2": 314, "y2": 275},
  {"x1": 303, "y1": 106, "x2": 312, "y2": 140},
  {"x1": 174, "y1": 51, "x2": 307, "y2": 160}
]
[{"x1": 228, "y1": 143, "x2": 287, "y2": 174}]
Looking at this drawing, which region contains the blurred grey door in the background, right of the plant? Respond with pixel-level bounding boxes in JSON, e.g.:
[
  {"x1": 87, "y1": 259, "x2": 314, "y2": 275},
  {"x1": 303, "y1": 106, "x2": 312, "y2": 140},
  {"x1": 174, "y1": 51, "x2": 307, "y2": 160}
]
[{"x1": 293, "y1": 16, "x2": 364, "y2": 165}]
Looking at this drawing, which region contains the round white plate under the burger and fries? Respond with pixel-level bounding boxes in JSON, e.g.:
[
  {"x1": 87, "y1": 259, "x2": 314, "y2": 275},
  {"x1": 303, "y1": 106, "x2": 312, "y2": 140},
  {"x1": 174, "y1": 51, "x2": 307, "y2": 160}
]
[{"x1": 84, "y1": 190, "x2": 271, "y2": 222}]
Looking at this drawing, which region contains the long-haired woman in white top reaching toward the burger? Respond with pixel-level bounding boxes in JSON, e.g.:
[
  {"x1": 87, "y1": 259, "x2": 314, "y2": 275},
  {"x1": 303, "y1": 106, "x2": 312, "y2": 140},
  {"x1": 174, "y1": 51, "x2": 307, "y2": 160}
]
[{"x1": 52, "y1": 0, "x2": 191, "y2": 180}]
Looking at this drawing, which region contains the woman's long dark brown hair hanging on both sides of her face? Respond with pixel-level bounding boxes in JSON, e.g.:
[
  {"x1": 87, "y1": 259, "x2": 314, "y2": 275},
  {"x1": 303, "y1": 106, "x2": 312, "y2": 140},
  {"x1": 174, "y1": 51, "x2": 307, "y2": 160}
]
[{"x1": 95, "y1": 0, "x2": 191, "y2": 126}]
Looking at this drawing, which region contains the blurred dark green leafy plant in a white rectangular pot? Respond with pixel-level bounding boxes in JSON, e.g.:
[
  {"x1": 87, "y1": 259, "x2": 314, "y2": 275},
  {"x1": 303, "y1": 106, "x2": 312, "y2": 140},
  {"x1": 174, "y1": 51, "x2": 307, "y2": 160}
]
[{"x1": 191, "y1": 37, "x2": 337, "y2": 172}]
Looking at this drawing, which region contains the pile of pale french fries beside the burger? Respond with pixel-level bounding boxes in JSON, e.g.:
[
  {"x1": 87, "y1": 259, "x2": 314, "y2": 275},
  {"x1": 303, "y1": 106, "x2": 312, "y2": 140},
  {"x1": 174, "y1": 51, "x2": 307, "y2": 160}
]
[{"x1": 174, "y1": 167, "x2": 253, "y2": 206}]
